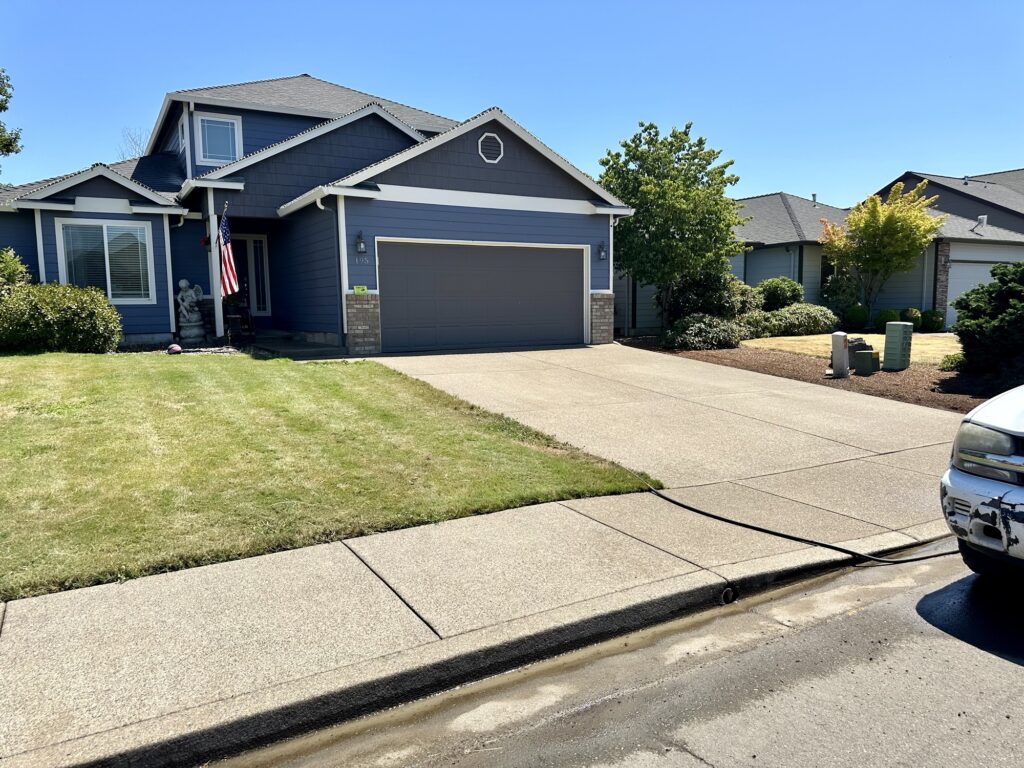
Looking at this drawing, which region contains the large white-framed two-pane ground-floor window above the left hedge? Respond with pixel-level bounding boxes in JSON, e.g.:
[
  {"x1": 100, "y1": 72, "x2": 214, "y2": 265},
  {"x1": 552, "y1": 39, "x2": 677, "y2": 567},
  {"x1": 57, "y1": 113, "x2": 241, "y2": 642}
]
[{"x1": 55, "y1": 219, "x2": 157, "y2": 304}]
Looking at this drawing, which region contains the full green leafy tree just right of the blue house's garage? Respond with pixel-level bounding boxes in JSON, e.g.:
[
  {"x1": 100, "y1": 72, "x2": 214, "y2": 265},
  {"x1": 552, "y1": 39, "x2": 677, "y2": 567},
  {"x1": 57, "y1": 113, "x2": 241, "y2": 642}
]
[{"x1": 600, "y1": 123, "x2": 744, "y2": 324}]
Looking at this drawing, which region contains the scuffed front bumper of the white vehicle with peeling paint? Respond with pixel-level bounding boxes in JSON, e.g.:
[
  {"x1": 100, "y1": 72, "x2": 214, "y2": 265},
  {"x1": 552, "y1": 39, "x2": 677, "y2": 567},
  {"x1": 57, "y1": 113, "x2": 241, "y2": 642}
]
[{"x1": 940, "y1": 467, "x2": 1024, "y2": 560}]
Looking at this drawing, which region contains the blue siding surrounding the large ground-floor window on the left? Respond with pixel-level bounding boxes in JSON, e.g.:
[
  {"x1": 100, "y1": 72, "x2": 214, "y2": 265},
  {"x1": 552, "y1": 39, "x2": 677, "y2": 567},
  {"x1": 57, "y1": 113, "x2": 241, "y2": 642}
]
[{"x1": 42, "y1": 211, "x2": 172, "y2": 334}]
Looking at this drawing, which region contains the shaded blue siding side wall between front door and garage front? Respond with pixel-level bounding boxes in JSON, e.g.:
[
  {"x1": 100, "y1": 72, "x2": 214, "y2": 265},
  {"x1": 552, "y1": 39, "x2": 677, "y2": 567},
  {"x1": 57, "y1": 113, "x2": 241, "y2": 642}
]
[{"x1": 269, "y1": 206, "x2": 341, "y2": 335}]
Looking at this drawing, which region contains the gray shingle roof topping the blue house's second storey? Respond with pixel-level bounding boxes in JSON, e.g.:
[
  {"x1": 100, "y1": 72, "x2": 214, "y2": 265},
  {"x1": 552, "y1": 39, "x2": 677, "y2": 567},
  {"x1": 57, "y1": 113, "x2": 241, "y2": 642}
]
[{"x1": 168, "y1": 75, "x2": 458, "y2": 133}]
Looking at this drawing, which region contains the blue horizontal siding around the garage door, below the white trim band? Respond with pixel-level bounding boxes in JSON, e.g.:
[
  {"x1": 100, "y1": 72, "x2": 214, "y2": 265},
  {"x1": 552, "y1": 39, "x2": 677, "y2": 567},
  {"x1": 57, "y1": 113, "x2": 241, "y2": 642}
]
[{"x1": 345, "y1": 198, "x2": 611, "y2": 291}]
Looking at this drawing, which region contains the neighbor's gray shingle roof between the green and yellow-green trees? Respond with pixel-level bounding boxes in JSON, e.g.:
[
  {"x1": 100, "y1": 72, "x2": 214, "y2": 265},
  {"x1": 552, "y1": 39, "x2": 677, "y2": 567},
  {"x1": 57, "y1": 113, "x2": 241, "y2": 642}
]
[{"x1": 736, "y1": 193, "x2": 847, "y2": 246}]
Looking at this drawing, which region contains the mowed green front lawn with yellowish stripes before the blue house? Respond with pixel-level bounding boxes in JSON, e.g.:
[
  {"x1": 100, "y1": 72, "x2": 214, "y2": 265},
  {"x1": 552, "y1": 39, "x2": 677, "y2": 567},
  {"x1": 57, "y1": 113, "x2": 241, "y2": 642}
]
[{"x1": 0, "y1": 353, "x2": 641, "y2": 600}]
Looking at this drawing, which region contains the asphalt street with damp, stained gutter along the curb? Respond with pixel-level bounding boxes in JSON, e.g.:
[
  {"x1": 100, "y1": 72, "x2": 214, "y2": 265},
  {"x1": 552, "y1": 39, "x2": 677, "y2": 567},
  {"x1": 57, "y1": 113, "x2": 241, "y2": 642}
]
[{"x1": 223, "y1": 542, "x2": 1024, "y2": 768}]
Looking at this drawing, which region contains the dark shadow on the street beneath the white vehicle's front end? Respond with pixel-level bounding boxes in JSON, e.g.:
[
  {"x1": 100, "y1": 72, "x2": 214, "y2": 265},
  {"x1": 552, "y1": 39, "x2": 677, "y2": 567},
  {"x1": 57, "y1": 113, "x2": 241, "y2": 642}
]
[{"x1": 918, "y1": 575, "x2": 1024, "y2": 666}]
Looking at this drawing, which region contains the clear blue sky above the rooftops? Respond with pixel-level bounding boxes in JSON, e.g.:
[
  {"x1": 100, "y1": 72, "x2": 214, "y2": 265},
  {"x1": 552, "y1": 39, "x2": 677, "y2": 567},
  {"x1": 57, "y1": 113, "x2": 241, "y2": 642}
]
[{"x1": 0, "y1": 0, "x2": 1024, "y2": 206}]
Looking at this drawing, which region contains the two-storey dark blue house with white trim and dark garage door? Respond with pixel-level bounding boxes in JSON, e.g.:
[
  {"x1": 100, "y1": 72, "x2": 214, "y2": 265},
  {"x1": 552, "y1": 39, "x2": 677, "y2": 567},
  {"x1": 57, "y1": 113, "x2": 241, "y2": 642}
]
[{"x1": 0, "y1": 75, "x2": 632, "y2": 354}]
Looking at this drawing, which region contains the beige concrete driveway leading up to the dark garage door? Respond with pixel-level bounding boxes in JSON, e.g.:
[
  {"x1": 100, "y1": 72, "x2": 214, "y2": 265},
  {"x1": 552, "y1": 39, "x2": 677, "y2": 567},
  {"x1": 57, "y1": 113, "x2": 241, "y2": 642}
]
[{"x1": 378, "y1": 344, "x2": 961, "y2": 540}]
